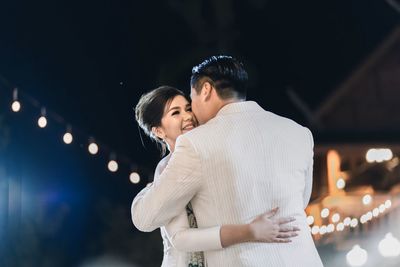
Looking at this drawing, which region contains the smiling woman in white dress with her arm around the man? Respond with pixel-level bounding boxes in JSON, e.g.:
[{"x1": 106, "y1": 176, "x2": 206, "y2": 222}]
[{"x1": 135, "y1": 86, "x2": 297, "y2": 267}]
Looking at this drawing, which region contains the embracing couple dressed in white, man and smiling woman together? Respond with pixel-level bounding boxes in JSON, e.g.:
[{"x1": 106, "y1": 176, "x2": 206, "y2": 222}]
[{"x1": 131, "y1": 56, "x2": 322, "y2": 267}]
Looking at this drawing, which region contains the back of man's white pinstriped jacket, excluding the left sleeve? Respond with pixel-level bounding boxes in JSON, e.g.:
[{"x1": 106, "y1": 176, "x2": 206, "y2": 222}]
[{"x1": 183, "y1": 102, "x2": 322, "y2": 267}]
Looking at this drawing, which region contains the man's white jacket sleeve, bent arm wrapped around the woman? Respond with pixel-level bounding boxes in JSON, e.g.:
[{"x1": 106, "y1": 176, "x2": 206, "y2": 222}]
[{"x1": 131, "y1": 136, "x2": 202, "y2": 232}]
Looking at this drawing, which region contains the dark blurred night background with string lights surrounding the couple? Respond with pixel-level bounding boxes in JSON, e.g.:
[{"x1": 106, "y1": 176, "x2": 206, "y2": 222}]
[{"x1": 0, "y1": 0, "x2": 400, "y2": 267}]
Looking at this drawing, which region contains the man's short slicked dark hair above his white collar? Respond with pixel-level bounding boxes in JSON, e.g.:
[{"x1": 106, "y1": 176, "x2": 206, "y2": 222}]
[{"x1": 190, "y1": 56, "x2": 248, "y2": 99}]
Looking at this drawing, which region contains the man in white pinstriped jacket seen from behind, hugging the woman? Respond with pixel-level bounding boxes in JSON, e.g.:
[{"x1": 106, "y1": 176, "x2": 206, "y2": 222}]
[{"x1": 132, "y1": 56, "x2": 322, "y2": 266}]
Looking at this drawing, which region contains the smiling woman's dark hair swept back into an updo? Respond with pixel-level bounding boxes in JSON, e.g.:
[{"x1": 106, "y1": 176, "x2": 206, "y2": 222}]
[{"x1": 135, "y1": 86, "x2": 190, "y2": 156}]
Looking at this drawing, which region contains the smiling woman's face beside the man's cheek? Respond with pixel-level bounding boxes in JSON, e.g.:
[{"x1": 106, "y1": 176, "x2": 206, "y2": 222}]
[{"x1": 154, "y1": 95, "x2": 197, "y2": 151}]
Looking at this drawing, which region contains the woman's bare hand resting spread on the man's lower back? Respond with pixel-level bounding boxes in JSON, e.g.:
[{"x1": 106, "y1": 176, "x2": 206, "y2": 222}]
[{"x1": 249, "y1": 208, "x2": 300, "y2": 243}]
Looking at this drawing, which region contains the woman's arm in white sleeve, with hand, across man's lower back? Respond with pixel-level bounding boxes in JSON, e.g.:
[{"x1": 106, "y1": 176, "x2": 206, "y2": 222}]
[{"x1": 165, "y1": 209, "x2": 299, "y2": 252}]
